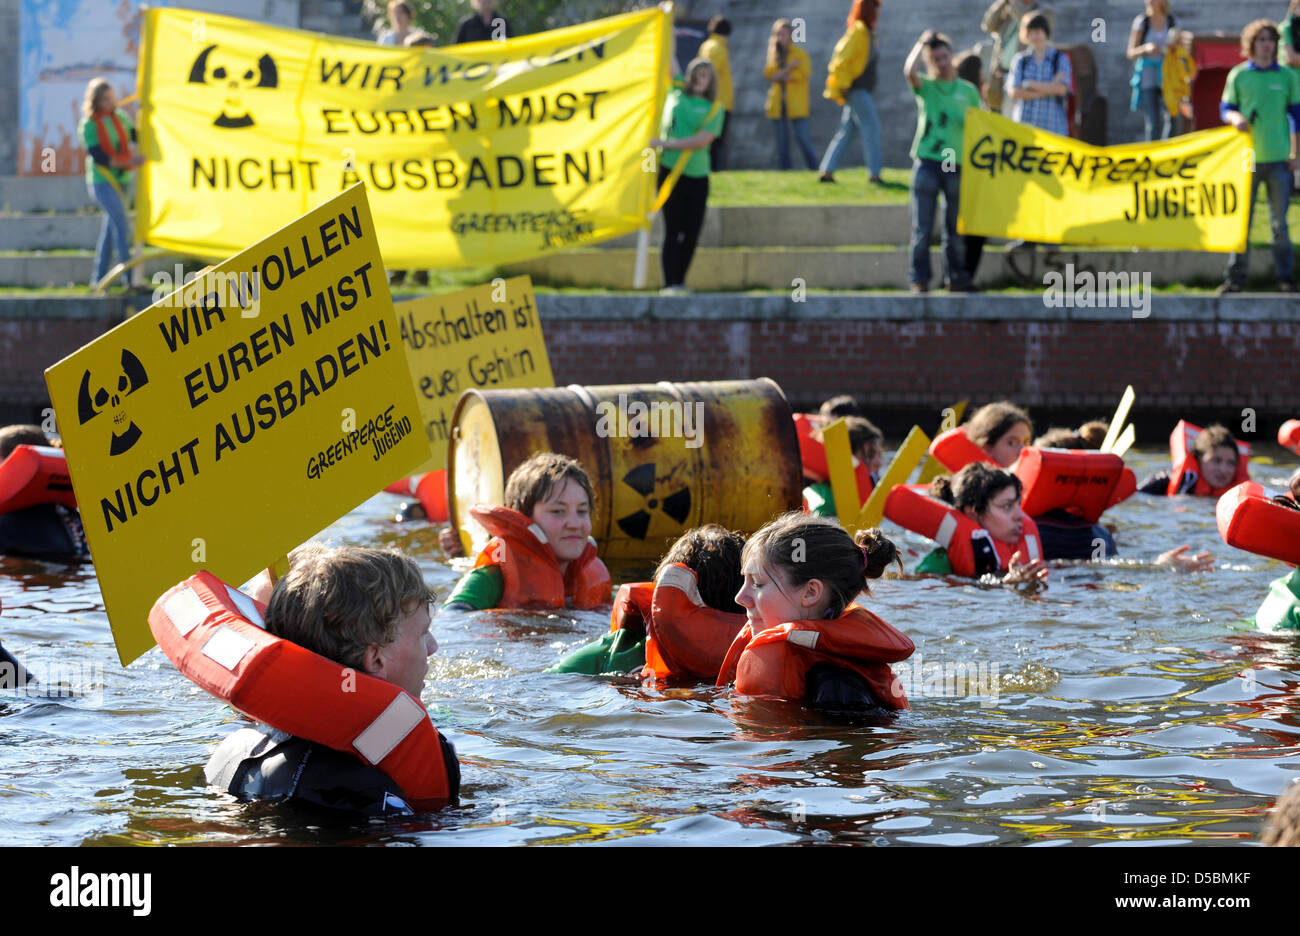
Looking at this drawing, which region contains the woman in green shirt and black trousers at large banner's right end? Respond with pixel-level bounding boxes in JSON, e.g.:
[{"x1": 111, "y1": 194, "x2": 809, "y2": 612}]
[{"x1": 650, "y1": 59, "x2": 724, "y2": 294}]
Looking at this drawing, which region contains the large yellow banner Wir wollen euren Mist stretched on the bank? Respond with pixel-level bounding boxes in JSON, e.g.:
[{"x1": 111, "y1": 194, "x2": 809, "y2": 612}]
[{"x1": 137, "y1": 8, "x2": 672, "y2": 269}]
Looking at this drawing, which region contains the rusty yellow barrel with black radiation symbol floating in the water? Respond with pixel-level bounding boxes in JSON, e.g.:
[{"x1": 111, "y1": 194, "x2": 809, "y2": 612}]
[{"x1": 447, "y1": 377, "x2": 802, "y2": 559}]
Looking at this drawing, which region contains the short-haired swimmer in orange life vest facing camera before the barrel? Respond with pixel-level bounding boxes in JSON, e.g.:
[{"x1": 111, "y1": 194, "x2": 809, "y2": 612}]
[{"x1": 443, "y1": 452, "x2": 610, "y2": 611}]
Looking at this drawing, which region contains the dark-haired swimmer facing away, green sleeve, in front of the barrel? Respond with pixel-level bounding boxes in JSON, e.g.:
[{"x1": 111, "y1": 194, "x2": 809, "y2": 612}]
[{"x1": 546, "y1": 524, "x2": 745, "y2": 685}]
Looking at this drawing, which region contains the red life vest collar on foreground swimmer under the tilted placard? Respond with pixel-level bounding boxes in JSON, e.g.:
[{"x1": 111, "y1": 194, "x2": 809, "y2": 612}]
[{"x1": 150, "y1": 572, "x2": 451, "y2": 809}]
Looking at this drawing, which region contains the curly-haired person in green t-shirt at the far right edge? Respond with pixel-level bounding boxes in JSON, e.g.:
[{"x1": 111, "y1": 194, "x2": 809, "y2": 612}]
[{"x1": 1219, "y1": 20, "x2": 1300, "y2": 295}]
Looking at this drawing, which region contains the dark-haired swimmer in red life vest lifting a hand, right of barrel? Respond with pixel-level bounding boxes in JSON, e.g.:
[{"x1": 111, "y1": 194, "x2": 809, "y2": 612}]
[{"x1": 917, "y1": 462, "x2": 1048, "y2": 585}]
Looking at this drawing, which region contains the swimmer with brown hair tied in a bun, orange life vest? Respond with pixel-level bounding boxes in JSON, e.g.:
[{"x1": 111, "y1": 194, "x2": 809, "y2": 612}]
[{"x1": 718, "y1": 512, "x2": 915, "y2": 709}]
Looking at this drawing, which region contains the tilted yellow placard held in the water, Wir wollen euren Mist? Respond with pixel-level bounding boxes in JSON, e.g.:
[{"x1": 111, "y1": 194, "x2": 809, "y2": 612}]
[{"x1": 46, "y1": 185, "x2": 428, "y2": 664}]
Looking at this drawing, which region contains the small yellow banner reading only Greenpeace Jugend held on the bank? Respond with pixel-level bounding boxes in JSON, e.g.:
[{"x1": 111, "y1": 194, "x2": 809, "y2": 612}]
[{"x1": 957, "y1": 109, "x2": 1251, "y2": 251}]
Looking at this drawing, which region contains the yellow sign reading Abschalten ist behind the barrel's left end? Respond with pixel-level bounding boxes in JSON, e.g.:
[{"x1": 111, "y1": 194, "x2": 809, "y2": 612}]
[{"x1": 397, "y1": 276, "x2": 555, "y2": 472}]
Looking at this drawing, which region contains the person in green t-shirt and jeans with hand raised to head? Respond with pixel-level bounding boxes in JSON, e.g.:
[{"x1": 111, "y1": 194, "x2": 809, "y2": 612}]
[{"x1": 904, "y1": 30, "x2": 980, "y2": 293}]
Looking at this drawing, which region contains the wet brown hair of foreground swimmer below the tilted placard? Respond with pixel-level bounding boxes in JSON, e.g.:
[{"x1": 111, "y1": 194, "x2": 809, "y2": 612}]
[{"x1": 267, "y1": 542, "x2": 436, "y2": 672}]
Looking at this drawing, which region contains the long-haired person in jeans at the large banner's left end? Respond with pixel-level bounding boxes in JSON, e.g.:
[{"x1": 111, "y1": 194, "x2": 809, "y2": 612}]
[{"x1": 78, "y1": 78, "x2": 144, "y2": 292}]
